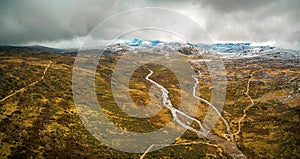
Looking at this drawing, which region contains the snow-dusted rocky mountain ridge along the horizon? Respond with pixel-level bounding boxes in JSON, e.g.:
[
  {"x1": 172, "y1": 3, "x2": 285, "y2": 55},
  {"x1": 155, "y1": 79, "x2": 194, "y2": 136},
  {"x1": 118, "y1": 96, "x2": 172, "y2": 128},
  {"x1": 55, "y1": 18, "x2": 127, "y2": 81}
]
[{"x1": 105, "y1": 38, "x2": 300, "y2": 60}]
